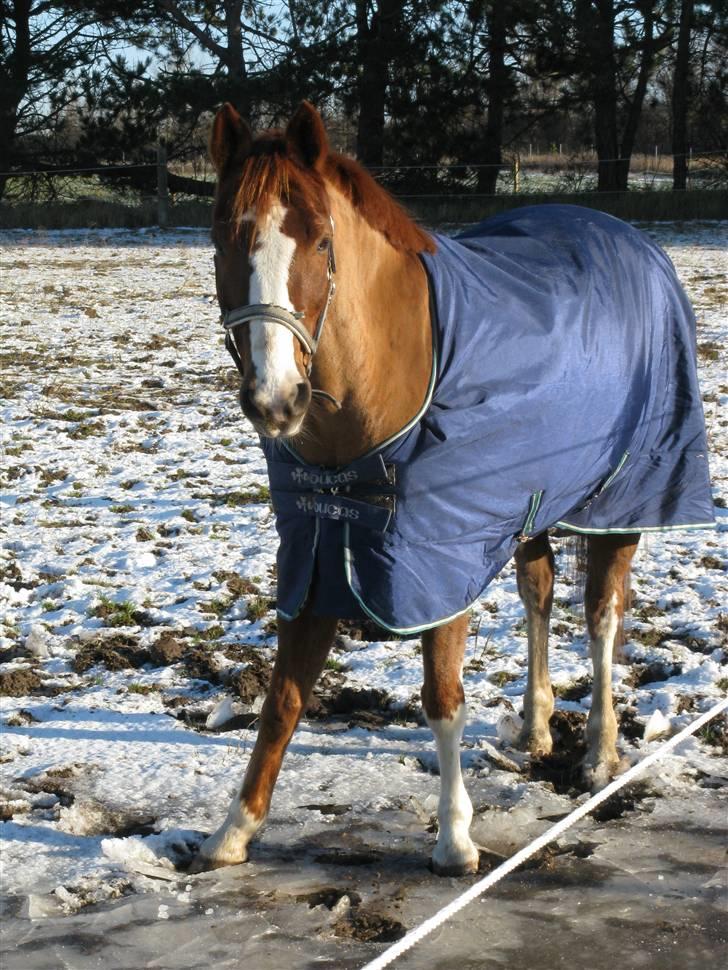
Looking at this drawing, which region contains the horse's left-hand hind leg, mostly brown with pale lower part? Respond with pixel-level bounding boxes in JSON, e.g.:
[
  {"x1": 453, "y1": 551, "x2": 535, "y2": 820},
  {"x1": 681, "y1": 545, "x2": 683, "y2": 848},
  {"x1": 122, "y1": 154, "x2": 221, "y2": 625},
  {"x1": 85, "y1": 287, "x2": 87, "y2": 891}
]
[{"x1": 516, "y1": 532, "x2": 554, "y2": 757}]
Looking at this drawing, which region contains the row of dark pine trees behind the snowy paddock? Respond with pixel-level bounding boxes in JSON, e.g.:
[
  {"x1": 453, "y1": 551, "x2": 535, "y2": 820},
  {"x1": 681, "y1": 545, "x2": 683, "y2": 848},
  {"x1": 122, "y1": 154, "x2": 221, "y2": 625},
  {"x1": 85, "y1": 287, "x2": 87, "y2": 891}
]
[{"x1": 0, "y1": 0, "x2": 728, "y2": 220}]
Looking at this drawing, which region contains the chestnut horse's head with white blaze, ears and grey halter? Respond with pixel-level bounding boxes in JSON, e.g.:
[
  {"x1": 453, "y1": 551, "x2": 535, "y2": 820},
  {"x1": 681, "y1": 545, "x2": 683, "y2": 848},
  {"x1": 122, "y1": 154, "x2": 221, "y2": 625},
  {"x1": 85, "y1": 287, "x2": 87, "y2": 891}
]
[{"x1": 210, "y1": 102, "x2": 335, "y2": 438}]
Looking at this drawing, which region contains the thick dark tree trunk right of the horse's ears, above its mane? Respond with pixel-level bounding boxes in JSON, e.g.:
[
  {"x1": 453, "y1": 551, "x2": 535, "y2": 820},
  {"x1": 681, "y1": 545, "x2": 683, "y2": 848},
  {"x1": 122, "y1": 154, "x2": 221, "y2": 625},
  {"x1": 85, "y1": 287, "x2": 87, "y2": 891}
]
[{"x1": 356, "y1": 0, "x2": 404, "y2": 165}]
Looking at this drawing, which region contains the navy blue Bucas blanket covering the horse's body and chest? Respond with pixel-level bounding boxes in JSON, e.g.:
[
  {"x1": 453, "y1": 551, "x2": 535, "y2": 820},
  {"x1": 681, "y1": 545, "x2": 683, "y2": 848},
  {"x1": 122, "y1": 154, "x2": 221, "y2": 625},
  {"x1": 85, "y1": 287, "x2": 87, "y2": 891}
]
[{"x1": 263, "y1": 206, "x2": 713, "y2": 633}]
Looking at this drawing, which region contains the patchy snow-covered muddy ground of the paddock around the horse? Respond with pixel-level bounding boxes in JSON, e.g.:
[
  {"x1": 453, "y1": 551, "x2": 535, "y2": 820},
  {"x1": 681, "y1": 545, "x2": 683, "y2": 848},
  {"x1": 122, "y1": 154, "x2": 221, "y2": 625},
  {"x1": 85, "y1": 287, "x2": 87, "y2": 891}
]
[{"x1": 0, "y1": 223, "x2": 728, "y2": 970}]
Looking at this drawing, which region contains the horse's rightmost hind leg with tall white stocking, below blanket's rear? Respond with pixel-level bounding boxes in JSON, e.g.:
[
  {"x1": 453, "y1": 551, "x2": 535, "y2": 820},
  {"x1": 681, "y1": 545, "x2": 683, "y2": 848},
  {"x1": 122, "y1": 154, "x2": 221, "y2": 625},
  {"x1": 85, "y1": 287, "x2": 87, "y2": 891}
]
[{"x1": 584, "y1": 533, "x2": 640, "y2": 790}]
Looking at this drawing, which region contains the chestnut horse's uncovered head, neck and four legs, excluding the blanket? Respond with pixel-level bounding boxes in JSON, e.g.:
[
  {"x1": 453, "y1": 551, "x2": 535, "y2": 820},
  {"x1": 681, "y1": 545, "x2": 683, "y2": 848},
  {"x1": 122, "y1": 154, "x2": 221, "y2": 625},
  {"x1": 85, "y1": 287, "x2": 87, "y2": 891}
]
[{"x1": 194, "y1": 102, "x2": 664, "y2": 875}]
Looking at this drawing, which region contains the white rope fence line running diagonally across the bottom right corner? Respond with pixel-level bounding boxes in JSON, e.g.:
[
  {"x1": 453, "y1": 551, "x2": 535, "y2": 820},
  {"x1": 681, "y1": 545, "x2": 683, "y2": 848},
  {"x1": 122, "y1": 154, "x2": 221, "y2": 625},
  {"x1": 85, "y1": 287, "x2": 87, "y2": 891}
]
[{"x1": 362, "y1": 698, "x2": 728, "y2": 970}]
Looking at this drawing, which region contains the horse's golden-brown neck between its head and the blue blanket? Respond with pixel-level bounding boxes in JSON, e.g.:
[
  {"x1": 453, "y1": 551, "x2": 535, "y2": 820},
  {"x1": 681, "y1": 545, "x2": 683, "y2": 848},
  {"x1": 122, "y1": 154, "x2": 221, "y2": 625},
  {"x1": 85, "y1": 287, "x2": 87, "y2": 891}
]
[{"x1": 295, "y1": 198, "x2": 432, "y2": 465}]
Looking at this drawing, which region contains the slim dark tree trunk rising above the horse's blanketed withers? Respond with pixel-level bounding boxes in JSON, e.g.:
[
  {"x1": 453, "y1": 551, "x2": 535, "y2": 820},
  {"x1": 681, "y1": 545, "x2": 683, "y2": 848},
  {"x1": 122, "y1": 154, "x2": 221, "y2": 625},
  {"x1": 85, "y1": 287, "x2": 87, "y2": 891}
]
[{"x1": 478, "y1": 0, "x2": 508, "y2": 195}]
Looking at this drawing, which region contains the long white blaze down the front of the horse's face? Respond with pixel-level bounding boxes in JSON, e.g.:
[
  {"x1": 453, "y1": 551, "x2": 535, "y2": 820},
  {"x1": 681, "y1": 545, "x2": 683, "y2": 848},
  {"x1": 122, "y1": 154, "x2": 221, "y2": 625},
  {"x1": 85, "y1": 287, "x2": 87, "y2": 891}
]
[{"x1": 250, "y1": 205, "x2": 302, "y2": 407}]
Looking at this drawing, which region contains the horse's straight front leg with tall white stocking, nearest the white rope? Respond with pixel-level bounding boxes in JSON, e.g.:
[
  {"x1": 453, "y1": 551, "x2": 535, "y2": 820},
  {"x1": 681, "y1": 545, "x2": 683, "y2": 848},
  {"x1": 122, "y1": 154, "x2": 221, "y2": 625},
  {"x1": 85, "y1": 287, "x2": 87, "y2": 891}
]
[{"x1": 422, "y1": 616, "x2": 478, "y2": 876}]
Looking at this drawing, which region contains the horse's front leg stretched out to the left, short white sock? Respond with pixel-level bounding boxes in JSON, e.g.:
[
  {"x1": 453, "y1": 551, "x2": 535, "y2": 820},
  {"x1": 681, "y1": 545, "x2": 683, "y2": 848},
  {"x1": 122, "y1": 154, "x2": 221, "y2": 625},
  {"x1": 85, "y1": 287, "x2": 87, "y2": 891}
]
[{"x1": 192, "y1": 610, "x2": 336, "y2": 872}]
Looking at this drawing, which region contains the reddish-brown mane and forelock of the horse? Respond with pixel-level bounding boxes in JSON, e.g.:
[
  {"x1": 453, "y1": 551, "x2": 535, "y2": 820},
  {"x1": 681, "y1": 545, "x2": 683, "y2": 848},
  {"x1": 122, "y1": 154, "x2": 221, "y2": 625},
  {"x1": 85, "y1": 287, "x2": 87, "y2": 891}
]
[{"x1": 233, "y1": 131, "x2": 435, "y2": 253}]
